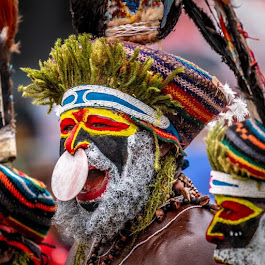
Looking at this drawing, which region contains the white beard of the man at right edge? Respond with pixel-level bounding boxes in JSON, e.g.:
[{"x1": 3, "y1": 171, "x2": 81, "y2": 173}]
[{"x1": 214, "y1": 214, "x2": 265, "y2": 265}]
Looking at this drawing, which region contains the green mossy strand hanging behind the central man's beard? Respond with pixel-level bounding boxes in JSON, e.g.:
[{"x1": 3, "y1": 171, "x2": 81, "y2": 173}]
[{"x1": 134, "y1": 151, "x2": 177, "y2": 233}]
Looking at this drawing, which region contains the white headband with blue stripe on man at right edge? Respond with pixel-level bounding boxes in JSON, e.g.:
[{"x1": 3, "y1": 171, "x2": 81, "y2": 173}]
[{"x1": 209, "y1": 171, "x2": 265, "y2": 198}]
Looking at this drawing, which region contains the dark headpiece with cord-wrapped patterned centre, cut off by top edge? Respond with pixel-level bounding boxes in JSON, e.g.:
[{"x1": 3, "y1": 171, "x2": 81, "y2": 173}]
[{"x1": 70, "y1": 0, "x2": 182, "y2": 43}]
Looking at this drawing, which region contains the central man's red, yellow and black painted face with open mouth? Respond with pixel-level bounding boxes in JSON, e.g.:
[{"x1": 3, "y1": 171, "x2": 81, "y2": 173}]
[{"x1": 60, "y1": 108, "x2": 138, "y2": 202}]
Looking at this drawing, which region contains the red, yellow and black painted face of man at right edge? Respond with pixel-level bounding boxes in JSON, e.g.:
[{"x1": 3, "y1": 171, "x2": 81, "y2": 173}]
[{"x1": 206, "y1": 195, "x2": 265, "y2": 265}]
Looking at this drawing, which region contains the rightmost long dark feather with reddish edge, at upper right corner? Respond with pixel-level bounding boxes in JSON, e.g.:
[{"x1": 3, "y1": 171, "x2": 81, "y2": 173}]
[{"x1": 215, "y1": 0, "x2": 265, "y2": 124}]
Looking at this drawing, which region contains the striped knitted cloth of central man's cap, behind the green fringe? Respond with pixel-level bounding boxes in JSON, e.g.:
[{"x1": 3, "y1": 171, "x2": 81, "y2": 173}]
[{"x1": 124, "y1": 42, "x2": 227, "y2": 149}]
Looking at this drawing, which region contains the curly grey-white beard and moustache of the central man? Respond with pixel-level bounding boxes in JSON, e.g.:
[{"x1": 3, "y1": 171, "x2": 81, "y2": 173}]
[{"x1": 53, "y1": 131, "x2": 155, "y2": 240}]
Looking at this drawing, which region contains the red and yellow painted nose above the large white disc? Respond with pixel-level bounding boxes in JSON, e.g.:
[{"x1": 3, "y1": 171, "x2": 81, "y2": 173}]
[{"x1": 64, "y1": 122, "x2": 90, "y2": 155}]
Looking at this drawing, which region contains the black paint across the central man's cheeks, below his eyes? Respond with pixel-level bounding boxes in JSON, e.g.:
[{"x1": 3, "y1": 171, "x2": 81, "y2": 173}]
[{"x1": 60, "y1": 126, "x2": 128, "y2": 174}]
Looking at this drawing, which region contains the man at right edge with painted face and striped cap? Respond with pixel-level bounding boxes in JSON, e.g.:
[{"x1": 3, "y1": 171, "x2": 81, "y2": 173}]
[{"x1": 206, "y1": 119, "x2": 265, "y2": 265}]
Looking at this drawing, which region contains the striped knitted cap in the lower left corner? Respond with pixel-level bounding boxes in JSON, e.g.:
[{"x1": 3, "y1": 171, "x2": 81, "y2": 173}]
[{"x1": 0, "y1": 164, "x2": 55, "y2": 243}]
